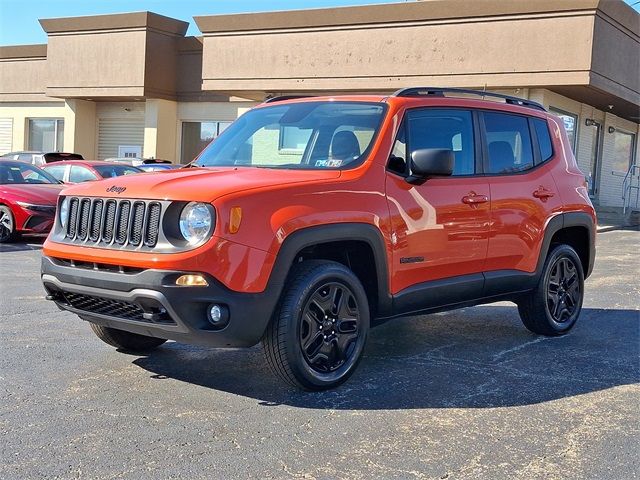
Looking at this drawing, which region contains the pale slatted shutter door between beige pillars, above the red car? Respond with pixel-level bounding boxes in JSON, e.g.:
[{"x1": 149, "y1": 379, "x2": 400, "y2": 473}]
[{"x1": 97, "y1": 103, "x2": 144, "y2": 160}]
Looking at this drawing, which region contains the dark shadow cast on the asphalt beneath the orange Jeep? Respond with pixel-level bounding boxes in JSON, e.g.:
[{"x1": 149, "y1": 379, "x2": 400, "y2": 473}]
[{"x1": 133, "y1": 305, "x2": 640, "y2": 410}]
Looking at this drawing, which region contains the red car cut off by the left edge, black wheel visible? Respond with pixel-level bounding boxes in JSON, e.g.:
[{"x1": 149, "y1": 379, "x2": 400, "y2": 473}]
[{"x1": 0, "y1": 160, "x2": 64, "y2": 243}]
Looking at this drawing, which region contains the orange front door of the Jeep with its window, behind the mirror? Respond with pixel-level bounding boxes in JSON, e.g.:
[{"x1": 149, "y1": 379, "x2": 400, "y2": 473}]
[{"x1": 386, "y1": 107, "x2": 490, "y2": 296}]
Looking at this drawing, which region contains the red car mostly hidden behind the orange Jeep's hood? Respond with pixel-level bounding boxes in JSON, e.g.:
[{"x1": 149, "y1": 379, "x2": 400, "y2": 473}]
[{"x1": 42, "y1": 160, "x2": 142, "y2": 183}]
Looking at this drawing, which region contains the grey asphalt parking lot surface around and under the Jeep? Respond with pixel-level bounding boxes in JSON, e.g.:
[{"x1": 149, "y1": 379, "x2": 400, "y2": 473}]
[{"x1": 0, "y1": 230, "x2": 640, "y2": 479}]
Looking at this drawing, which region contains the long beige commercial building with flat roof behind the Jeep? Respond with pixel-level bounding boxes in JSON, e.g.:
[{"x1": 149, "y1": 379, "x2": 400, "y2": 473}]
[{"x1": 0, "y1": 0, "x2": 640, "y2": 207}]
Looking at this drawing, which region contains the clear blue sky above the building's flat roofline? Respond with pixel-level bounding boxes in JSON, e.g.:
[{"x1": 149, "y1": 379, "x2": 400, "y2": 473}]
[{"x1": 0, "y1": 0, "x2": 640, "y2": 45}]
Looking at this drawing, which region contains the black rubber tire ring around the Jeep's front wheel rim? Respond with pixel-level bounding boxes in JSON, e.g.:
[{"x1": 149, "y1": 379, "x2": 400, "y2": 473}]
[{"x1": 281, "y1": 264, "x2": 369, "y2": 389}]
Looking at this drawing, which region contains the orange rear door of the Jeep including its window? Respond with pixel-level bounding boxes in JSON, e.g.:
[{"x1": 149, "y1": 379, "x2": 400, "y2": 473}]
[{"x1": 481, "y1": 111, "x2": 561, "y2": 280}]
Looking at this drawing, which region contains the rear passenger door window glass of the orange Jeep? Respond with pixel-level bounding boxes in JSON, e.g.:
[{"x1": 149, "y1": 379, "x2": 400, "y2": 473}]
[{"x1": 483, "y1": 112, "x2": 533, "y2": 174}]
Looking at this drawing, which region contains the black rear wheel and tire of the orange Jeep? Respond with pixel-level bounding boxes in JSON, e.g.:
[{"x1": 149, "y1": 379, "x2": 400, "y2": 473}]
[{"x1": 518, "y1": 245, "x2": 584, "y2": 336}]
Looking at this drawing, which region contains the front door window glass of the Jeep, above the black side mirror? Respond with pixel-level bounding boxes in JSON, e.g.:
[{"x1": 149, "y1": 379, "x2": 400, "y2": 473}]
[{"x1": 406, "y1": 108, "x2": 475, "y2": 175}]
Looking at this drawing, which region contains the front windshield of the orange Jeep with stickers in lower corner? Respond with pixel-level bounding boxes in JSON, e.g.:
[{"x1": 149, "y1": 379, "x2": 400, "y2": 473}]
[{"x1": 194, "y1": 102, "x2": 384, "y2": 169}]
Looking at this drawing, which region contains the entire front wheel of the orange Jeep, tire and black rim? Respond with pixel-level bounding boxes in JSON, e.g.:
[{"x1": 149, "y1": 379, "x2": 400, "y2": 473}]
[{"x1": 263, "y1": 260, "x2": 369, "y2": 390}]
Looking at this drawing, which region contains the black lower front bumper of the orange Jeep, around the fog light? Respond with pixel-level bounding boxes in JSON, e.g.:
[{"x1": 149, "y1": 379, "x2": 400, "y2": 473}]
[{"x1": 41, "y1": 256, "x2": 277, "y2": 347}]
